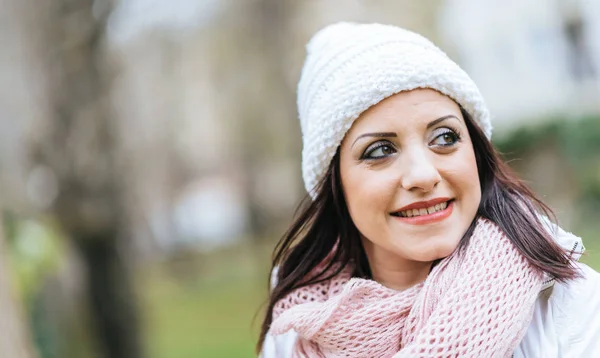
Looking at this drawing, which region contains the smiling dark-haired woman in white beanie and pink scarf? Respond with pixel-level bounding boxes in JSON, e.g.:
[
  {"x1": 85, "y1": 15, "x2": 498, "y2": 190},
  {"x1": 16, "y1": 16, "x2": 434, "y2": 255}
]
[{"x1": 258, "y1": 23, "x2": 600, "y2": 358}]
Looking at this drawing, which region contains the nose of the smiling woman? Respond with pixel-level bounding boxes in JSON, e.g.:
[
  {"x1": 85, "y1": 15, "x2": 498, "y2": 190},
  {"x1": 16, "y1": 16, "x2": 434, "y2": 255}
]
[{"x1": 401, "y1": 150, "x2": 442, "y2": 192}]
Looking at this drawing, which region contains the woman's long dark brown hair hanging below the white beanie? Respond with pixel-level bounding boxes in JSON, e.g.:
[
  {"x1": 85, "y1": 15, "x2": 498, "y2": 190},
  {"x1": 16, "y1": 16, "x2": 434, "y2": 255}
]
[{"x1": 256, "y1": 108, "x2": 578, "y2": 352}]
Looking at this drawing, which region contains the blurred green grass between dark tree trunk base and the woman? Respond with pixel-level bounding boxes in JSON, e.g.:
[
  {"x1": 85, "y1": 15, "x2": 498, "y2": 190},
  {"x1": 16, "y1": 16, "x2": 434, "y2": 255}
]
[{"x1": 141, "y1": 248, "x2": 267, "y2": 358}]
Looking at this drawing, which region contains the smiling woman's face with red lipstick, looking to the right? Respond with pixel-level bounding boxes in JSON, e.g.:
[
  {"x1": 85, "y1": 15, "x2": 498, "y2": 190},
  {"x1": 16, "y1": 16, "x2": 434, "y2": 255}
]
[{"x1": 340, "y1": 89, "x2": 481, "y2": 268}]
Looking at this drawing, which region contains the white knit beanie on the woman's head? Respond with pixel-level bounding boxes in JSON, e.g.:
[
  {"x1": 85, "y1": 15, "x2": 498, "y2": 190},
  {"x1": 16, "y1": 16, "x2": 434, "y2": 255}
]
[{"x1": 298, "y1": 22, "x2": 492, "y2": 199}]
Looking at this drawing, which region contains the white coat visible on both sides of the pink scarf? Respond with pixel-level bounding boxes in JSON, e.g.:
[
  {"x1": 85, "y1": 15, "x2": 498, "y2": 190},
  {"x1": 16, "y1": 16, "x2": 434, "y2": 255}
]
[{"x1": 261, "y1": 225, "x2": 600, "y2": 358}]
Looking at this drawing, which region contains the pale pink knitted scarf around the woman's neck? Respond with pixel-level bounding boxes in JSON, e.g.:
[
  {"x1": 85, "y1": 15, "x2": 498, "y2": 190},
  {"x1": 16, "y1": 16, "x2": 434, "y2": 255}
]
[{"x1": 271, "y1": 219, "x2": 543, "y2": 358}]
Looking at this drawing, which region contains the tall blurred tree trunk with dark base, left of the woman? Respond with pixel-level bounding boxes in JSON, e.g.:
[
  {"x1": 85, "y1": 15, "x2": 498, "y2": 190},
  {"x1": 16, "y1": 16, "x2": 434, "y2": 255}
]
[{"x1": 32, "y1": 0, "x2": 142, "y2": 358}]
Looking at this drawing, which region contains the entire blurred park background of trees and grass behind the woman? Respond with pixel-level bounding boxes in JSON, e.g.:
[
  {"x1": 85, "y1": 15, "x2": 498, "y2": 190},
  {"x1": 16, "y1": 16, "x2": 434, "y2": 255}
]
[{"x1": 0, "y1": 0, "x2": 600, "y2": 358}]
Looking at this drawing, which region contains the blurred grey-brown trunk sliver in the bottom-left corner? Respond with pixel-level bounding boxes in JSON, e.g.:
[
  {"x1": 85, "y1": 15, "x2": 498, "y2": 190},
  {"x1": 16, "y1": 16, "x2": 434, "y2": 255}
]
[{"x1": 0, "y1": 230, "x2": 35, "y2": 358}]
